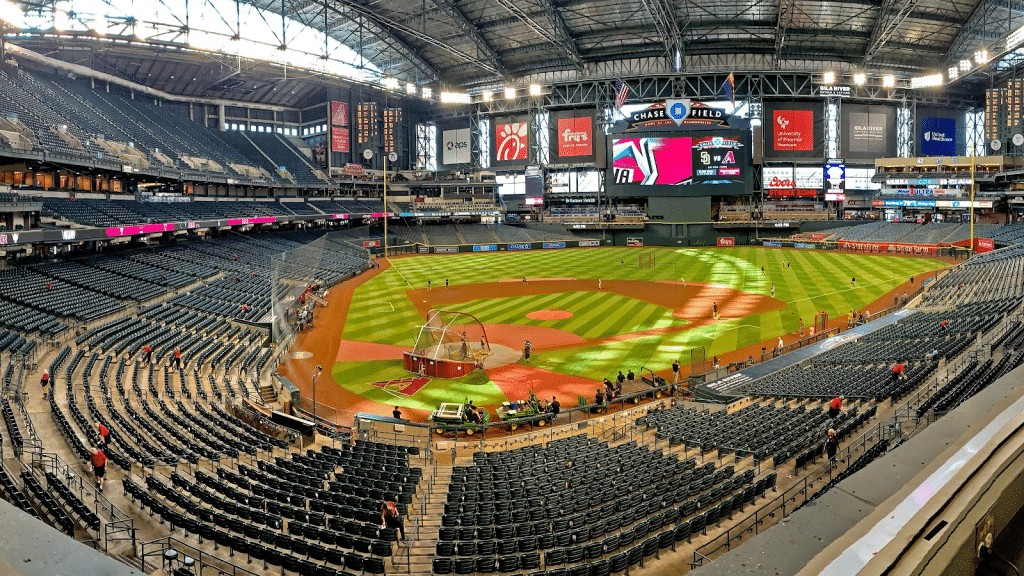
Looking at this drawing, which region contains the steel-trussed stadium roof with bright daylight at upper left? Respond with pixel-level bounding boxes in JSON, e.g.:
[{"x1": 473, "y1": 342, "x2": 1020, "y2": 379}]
[{"x1": 0, "y1": 0, "x2": 1011, "y2": 101}]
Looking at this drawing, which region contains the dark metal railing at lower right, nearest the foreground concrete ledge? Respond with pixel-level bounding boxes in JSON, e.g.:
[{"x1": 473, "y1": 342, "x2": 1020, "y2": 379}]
[{"x1": 689, "y1": 422, "x2": 891, "y2": 568}]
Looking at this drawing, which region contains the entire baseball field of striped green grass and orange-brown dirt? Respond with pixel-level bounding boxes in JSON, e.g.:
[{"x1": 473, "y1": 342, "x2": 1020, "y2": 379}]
[{"x1": 285, "y1": 242, "x2": 946, "y2": 419}]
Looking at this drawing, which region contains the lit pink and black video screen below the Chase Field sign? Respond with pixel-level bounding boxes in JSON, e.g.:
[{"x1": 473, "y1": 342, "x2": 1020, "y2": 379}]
[{"x1": 611, "y1": 135, "x2": 746, "y2": 187}]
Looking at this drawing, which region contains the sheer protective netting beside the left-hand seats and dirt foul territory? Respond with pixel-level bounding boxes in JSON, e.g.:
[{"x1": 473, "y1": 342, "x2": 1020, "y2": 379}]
[{"x1": 268, "y1": 233, "x2": 372, "y2": 346}]
